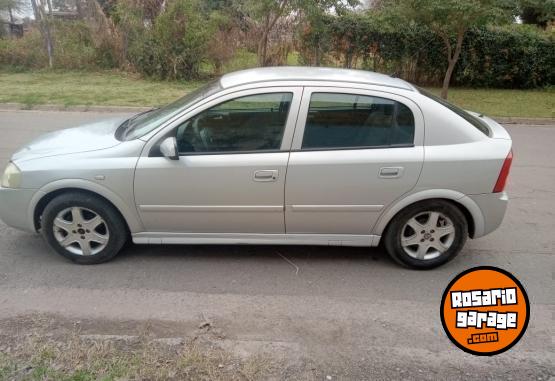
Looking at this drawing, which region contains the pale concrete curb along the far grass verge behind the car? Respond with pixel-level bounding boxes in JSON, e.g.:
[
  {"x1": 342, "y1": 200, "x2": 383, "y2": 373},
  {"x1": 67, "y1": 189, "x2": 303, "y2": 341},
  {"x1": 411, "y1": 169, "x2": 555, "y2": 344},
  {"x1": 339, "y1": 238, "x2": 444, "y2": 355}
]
[{"x1": 0, "y1": 103, "x2": 555, "y2": 126}]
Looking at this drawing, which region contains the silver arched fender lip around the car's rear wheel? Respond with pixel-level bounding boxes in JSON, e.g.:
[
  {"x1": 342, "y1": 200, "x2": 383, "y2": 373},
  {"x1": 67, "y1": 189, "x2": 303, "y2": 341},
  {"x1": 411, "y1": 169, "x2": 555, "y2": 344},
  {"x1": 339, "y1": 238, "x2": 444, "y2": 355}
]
[{"x1": 371, "y1": 189, "x2": 485, "y2": 238}]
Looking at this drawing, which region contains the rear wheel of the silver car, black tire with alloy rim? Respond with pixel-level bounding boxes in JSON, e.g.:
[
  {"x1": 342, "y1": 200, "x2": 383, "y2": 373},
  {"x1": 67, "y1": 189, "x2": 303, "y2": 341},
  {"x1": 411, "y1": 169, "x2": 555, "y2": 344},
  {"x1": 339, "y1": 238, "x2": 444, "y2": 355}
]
[{"x1": 384, "y1": 200, "x2": 468, "y2": 269}]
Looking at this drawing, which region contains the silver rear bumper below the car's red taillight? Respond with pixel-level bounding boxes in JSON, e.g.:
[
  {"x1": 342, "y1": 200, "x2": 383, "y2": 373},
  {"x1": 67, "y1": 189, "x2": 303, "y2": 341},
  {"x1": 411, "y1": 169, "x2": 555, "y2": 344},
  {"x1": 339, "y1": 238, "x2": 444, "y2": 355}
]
[{"x1": 467, "y1": 192, "x2": 509, "y2": 238}]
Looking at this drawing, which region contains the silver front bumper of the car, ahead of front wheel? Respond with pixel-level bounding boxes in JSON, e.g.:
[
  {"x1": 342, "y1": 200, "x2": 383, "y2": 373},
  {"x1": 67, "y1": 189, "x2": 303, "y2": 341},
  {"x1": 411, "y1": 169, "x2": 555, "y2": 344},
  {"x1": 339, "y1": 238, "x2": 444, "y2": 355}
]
[{"x1": 0, "y1": 187, "x2": 37, "y2": 233}]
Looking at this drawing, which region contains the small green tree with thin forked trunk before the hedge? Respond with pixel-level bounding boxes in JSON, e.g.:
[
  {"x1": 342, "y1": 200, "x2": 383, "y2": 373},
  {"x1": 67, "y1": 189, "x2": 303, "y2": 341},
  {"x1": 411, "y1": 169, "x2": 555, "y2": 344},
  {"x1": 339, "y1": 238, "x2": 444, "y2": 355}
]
[{"x1": 384, "y1": 0, "x2": 515, "y2": 99}]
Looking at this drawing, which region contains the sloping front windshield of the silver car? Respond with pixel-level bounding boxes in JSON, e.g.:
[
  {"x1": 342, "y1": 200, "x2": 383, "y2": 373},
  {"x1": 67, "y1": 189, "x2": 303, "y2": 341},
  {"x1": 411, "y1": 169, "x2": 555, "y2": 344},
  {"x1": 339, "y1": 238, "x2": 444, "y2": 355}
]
[{"x1": 119, "y1": 79, "x2": 222, "y2": 140}]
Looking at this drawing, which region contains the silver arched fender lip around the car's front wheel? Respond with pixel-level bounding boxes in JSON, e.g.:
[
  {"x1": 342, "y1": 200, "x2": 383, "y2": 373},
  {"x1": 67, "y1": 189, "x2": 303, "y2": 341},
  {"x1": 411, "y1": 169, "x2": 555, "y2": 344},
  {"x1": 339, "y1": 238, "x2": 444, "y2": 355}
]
[{"x1": 27, "y1": 179, "x2": 144, "y2": 233}]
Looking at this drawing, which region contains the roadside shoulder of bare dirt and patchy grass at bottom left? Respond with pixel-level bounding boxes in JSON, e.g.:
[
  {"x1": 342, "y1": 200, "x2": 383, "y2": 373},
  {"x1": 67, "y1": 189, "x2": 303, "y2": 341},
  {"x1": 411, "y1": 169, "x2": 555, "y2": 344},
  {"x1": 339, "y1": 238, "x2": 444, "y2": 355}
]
[{"x1": 0, "y1": 315, "x2": 315, "y2": 380}]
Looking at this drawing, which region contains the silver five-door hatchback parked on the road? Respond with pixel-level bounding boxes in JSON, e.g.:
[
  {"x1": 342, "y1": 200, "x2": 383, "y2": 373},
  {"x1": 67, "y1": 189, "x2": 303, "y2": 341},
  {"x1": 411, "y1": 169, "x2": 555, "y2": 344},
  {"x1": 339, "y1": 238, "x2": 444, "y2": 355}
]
[{"x1": 0, "y1": 67, "x2": 512, "y2": 268}]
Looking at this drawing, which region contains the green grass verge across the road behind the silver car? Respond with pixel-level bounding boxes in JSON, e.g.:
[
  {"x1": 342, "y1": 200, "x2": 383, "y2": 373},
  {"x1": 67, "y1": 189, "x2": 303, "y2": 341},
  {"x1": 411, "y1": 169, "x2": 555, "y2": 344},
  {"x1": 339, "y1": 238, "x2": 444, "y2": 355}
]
[{"x1": 0, "y1": 69, "x2": 555, "y2": 118}]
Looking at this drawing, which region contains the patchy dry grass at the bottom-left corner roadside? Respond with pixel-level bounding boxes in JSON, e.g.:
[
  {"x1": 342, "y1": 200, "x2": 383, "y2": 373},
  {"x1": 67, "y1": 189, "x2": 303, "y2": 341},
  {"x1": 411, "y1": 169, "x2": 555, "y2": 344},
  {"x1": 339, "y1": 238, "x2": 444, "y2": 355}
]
[{"x1": 0, "y1": 320, "x2": 275, "y2": 381}]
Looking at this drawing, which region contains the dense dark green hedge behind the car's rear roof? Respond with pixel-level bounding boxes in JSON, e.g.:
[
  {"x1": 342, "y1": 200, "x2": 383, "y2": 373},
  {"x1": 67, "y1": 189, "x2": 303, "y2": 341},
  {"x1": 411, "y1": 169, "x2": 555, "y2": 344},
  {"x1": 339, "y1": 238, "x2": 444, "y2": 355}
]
[{"x1": 299, "y1": 14, "x2": 555, "y2": 88}]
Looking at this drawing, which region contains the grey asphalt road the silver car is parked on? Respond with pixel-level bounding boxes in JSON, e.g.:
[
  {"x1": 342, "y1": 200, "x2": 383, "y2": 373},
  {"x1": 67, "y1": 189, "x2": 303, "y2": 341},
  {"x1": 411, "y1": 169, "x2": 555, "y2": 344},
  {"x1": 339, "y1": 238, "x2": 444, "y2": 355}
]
[{"x1": 0, "y1": 111, "x2": 555, "y2": 380}]
